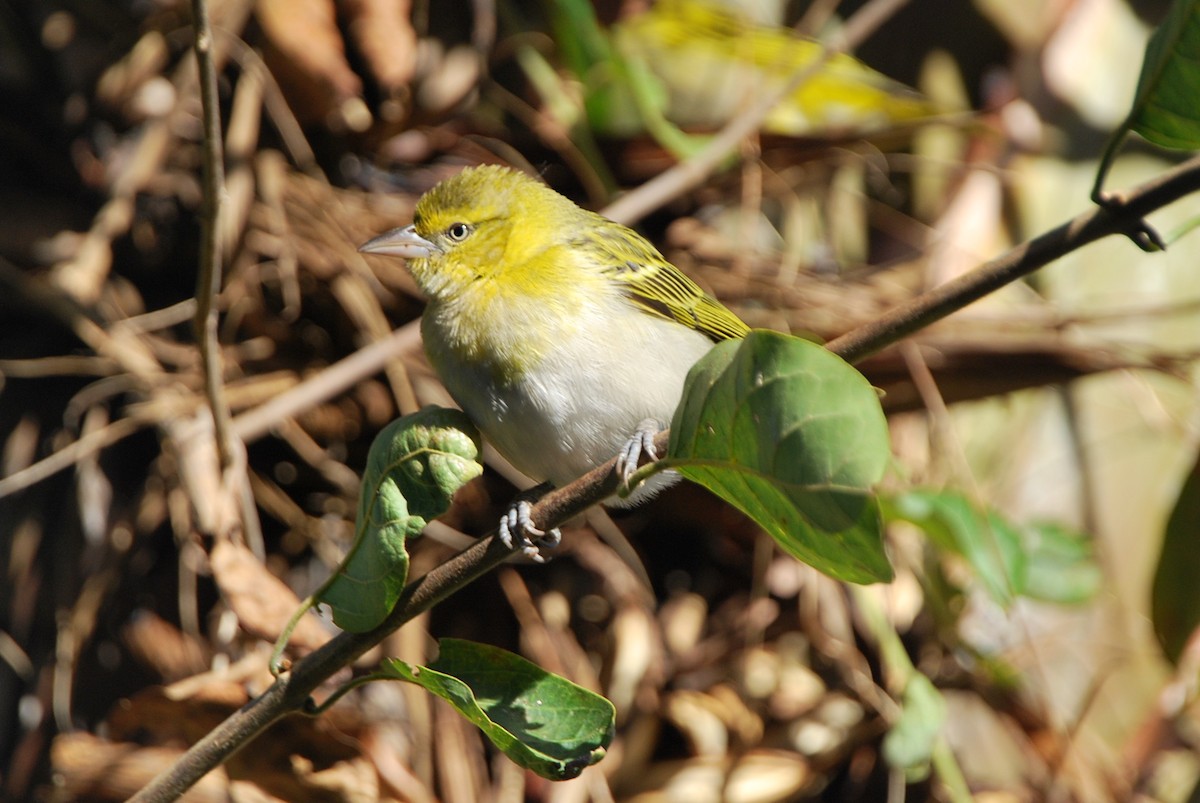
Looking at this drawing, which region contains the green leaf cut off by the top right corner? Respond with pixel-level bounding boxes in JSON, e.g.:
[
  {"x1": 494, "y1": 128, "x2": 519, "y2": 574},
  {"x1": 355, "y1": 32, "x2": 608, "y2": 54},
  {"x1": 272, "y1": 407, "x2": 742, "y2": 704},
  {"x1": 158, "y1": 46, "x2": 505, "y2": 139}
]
[{"x1": 1127, "y1": 0, "x2": 1200, "y2": 149}]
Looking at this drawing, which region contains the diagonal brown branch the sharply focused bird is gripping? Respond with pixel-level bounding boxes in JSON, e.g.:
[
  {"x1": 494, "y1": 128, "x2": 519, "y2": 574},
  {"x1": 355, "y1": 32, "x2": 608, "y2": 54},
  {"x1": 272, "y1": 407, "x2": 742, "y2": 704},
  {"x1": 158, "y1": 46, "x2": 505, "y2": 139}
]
[{"x1": 132, "y1": 144, "x2": 1200, "y2": 803}]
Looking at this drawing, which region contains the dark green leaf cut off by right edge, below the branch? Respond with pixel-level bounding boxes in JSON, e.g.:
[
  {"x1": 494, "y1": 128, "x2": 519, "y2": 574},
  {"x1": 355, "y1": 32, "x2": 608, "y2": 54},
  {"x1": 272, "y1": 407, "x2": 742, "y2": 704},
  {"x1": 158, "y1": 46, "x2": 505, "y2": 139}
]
[{"x1": 1151, "y1": 448, "x2": 1200, "y2": 663}]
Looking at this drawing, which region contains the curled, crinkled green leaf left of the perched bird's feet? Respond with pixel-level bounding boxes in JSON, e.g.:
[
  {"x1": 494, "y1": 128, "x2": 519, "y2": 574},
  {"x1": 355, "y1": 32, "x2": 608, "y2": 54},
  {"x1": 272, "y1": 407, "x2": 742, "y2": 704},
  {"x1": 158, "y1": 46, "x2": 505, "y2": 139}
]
[{"x1": 316, "y1": 407, "x2": 484, "y2": 633}]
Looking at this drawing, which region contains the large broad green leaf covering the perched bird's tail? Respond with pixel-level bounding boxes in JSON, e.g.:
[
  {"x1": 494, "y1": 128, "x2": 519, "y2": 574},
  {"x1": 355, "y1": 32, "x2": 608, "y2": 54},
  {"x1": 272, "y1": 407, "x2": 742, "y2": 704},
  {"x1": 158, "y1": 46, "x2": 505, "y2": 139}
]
[{"x1": 665, "y1": 330, "x2": 892, "y2": 583}]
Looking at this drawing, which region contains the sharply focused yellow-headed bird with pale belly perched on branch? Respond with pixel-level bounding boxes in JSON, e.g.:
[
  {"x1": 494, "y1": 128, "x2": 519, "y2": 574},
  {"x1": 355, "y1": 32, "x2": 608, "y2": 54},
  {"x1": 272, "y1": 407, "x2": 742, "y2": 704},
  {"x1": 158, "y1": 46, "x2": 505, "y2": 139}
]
[{"x1": 359, "y1": 164, "x2": 750, "y2": 561}]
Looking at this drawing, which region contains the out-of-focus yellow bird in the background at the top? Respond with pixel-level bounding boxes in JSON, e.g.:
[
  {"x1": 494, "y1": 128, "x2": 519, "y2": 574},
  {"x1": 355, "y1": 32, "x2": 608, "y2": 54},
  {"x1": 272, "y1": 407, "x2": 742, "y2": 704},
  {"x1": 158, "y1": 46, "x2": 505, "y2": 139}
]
[{"x1": 553, "y1": 0, "x2": 941, "y2": 144}]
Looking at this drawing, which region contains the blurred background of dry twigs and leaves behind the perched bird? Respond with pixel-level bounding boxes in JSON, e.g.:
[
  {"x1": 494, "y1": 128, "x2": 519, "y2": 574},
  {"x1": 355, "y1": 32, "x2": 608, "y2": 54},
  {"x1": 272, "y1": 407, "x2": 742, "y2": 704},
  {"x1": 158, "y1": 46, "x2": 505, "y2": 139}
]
[{"x1": 0, "y1": 0, "x2": 1200, "y2": 801}]
